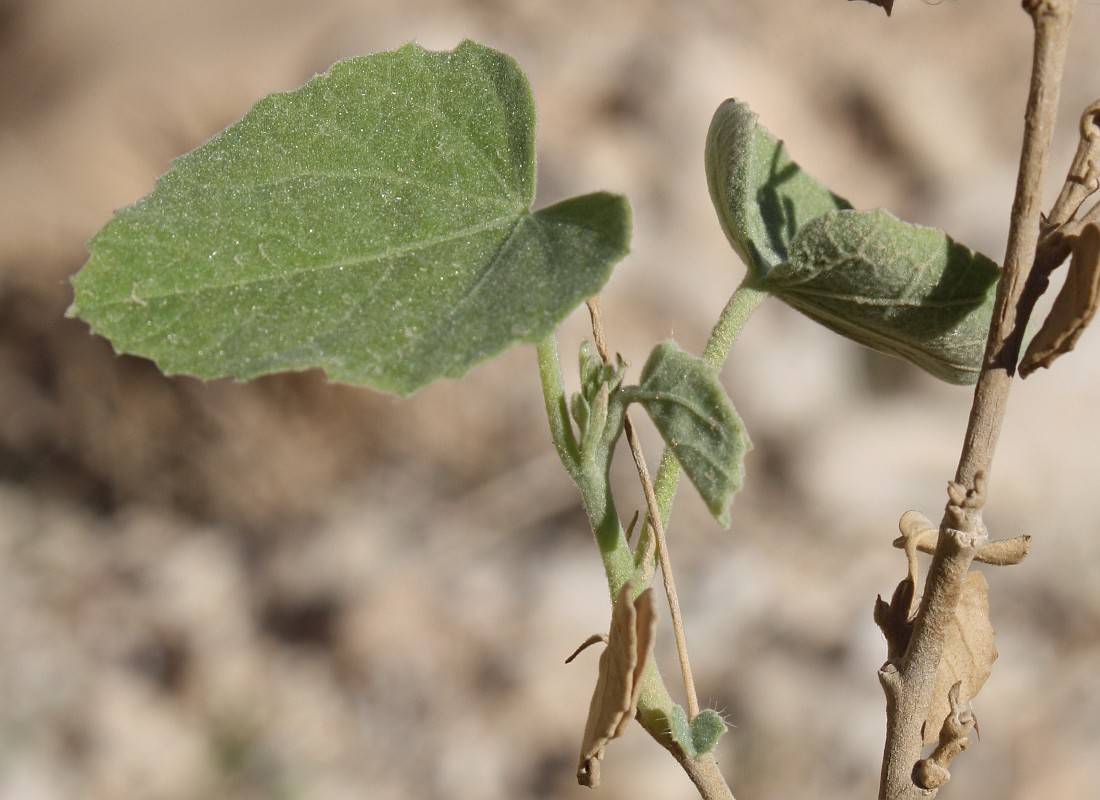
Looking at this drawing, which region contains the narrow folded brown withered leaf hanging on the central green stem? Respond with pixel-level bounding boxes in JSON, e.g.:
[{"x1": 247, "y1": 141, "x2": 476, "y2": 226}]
[{"x1": 576, "y1": 583, "x2": 657, "y2": 789}]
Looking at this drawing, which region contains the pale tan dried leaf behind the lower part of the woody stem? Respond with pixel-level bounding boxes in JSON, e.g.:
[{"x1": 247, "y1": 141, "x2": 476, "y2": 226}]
[{"x1": 924, "y1": 572, "x2": 997, "y2": 745}]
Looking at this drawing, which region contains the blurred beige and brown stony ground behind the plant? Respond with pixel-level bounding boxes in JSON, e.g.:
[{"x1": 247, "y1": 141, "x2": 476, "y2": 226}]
[{"x1": 0, "y1": 0, "x2": 1100, "y2": 800}]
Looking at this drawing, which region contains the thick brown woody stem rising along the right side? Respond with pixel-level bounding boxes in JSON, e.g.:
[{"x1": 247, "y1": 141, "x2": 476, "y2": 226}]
[{"x1": 879, "y1": 0, "x2": 1076, "y2": 800}]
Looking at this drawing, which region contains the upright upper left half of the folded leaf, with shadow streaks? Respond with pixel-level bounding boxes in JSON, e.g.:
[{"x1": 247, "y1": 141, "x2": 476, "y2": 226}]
[{"x1": 706, "y1": 100, "x2": 850, "y2": 277}]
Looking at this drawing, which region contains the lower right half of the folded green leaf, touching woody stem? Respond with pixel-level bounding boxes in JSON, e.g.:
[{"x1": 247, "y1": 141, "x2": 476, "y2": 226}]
[{"x1": 762, "y1": 210, "x2": 1000, "y2": 384}]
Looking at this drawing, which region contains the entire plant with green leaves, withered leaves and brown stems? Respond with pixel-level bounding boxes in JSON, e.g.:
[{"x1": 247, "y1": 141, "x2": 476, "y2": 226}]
[{"x1": 73, "y1": 1, "x2": 1100, "y2": 798}]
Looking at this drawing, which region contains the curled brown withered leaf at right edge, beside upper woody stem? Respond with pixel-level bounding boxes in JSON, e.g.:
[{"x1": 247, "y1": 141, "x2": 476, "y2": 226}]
[{"x1": 1020, "y1": 224, "x2": 1100, "y2": 377}]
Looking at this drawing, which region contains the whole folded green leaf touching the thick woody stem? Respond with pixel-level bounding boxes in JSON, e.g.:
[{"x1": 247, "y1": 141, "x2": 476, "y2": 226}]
[{"x1": 706, "y1": 100, "x2": 1000, "y2": 383}]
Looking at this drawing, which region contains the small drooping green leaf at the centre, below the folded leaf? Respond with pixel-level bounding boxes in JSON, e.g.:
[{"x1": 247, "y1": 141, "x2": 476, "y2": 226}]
[{"x1": 623, "y1": 341, "x2": 752, "y2": 525}]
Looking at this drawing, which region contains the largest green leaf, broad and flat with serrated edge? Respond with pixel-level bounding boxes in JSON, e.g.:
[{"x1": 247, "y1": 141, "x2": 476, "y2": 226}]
[{"x1": 70, "y1": 42, "x2": 630, "y2": 394}]
